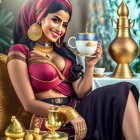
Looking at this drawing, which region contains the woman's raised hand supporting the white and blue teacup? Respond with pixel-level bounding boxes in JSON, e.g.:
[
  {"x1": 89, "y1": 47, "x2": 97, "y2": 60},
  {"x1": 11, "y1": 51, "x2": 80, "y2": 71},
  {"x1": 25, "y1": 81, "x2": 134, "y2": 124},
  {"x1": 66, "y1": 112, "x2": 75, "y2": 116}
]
[{"x1": 85, "y1": 43, "x2": 103, "y2": 67}]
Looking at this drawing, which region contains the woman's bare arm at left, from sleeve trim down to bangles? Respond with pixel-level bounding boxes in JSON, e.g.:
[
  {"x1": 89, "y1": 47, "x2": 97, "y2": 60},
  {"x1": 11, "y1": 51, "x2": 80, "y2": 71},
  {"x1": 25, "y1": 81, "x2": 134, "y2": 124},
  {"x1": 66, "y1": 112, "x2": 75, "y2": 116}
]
[{"x1": 7, "y1": 59, "x2": 51, "y2": 117}]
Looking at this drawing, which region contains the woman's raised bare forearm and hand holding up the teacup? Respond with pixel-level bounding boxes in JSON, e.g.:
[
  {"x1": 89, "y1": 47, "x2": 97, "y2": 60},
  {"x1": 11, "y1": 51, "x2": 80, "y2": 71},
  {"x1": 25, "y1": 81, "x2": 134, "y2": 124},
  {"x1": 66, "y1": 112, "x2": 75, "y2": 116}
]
[{"x1": 72, "y1": 43, "x2": 102, "y2": 99}]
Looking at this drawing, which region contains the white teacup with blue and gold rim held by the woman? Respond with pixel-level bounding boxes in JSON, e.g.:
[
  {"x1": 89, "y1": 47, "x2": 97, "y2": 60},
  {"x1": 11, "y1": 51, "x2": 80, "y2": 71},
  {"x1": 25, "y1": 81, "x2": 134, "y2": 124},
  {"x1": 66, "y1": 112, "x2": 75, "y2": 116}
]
[{"x1": 68, "y1": 31, "x2": 98, "y2": 55}]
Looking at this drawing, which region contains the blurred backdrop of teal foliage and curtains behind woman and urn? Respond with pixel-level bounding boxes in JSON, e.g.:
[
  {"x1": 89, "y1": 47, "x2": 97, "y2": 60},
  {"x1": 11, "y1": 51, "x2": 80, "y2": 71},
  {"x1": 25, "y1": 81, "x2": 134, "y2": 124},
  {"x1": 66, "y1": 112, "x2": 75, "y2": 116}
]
[{"x1": 0, "y1": 0, "x2": 140, "y2": 73}]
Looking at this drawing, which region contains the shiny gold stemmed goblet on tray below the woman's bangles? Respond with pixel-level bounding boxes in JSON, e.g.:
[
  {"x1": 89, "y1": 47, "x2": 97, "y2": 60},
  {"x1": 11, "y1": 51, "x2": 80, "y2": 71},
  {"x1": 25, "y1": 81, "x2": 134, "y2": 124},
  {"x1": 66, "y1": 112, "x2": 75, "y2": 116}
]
[{"x1": 43, "y1": 110, "x2": 68, "y2": 140}]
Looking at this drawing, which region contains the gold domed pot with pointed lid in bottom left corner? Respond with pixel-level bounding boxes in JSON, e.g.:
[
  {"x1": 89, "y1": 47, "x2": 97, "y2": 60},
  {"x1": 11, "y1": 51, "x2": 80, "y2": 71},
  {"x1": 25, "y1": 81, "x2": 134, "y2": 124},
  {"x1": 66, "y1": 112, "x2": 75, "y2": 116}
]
[{"x1": 5, "y1": 116, "x2": 25, "y2": 140}]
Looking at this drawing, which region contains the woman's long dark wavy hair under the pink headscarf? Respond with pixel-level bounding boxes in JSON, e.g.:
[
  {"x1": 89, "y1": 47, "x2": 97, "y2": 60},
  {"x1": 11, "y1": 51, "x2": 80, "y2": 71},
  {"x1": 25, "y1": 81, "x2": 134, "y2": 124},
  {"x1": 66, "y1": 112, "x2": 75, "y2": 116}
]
[{"x1": 13, "y1": 1, "x2": 83, "y2": 82}]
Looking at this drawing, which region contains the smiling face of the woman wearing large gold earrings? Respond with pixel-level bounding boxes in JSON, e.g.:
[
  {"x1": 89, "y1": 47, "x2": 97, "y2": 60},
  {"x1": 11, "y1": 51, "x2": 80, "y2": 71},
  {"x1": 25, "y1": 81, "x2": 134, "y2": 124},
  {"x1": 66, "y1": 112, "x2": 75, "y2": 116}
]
[{"x1": 41, "y1": 10, "x2": 70, "y2": 43}]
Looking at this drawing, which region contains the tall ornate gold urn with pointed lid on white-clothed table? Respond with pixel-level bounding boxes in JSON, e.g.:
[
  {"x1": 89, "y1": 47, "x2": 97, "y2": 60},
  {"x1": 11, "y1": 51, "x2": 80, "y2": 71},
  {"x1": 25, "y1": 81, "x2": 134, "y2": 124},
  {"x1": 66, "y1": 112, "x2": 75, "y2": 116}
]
[{"x1": 109, "y1": 0, "x2": 138, "y2": 79}]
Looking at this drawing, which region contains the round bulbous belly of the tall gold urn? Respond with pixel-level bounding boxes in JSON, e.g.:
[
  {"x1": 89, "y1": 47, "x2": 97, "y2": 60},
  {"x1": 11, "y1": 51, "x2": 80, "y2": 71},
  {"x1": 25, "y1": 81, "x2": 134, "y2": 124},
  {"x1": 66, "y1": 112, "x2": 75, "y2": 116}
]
[{"x1": 109, "y1": 37, "x2": 138, "y2": 64}]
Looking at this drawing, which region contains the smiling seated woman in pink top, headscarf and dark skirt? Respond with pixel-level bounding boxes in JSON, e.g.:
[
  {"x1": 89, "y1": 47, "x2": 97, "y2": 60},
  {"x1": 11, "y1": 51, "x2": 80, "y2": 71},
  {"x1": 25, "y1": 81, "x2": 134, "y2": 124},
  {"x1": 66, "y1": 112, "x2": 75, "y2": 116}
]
[{"x1": 7, "y1": 0, "x2": 140, "y2": 140}]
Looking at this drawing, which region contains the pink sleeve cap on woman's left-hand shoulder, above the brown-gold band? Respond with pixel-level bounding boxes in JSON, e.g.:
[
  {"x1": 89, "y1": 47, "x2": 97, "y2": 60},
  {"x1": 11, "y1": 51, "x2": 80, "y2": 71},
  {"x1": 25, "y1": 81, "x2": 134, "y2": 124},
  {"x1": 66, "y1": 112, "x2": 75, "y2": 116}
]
[{"x1": 8, "y1": 44, "x2": 29, "y2": 56}]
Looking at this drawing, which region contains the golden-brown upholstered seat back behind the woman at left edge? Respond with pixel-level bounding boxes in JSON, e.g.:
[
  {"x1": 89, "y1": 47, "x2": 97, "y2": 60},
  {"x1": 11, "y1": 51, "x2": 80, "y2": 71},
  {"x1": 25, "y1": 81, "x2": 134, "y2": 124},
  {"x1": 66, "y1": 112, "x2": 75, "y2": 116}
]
[{"x1": 0, "y1": 53, "x2": 32, "y2": 137}]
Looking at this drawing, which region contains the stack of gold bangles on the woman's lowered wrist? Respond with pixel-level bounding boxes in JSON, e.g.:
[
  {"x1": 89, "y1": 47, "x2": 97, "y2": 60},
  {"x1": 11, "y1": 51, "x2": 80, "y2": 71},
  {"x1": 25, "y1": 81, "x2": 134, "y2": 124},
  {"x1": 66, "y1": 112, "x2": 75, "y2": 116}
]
[{"x1": 52, "y1": 105, "x2": 79, "y2": 125}]
